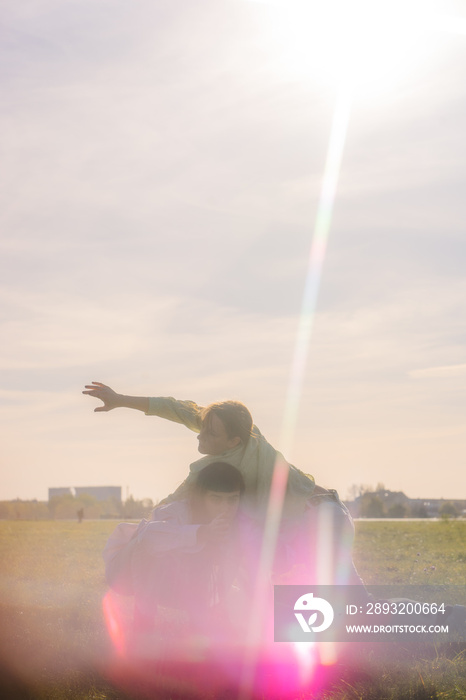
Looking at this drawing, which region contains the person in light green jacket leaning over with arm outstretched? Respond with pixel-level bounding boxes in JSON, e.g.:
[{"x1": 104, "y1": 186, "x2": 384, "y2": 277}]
[{"x1": 83, "y1": 382, "x2": 361, "y2": 584}]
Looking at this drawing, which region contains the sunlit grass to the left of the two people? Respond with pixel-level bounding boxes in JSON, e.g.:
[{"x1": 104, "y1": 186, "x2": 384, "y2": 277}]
[{"x1": 0, "y1": 521, "x2": 115, "y2": 700}]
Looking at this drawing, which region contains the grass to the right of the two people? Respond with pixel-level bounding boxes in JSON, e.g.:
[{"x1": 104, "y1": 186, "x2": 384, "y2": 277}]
[{"x1": 328, "y1": 520, "x2": 466, "y2": 700}]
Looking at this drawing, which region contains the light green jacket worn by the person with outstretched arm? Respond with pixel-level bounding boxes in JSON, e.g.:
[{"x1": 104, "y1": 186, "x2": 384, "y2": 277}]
[{"x1": 146, "y1": 397, "x2": 315, "y2": 519}]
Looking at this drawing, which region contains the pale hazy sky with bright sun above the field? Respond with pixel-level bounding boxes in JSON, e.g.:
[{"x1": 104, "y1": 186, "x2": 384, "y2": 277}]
[{"x1": 0, "y1": 0, "x2": 466, "y2": 500}]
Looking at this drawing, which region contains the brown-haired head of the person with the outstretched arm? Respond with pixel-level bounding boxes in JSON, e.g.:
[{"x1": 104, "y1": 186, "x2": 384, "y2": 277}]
[{"x1": 198, "y1": 401, "x2": 253, "y2": 455}]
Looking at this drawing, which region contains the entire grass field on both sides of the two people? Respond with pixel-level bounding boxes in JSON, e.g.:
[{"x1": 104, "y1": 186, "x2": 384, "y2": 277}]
[{"x1": 0, "y1": 520, "x2": 466, "y2": 700}]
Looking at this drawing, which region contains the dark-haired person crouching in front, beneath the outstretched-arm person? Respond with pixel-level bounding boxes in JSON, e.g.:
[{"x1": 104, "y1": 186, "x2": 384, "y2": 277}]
[{"x1": 104, "y1": 461, "x2": 256, "y2": 632}]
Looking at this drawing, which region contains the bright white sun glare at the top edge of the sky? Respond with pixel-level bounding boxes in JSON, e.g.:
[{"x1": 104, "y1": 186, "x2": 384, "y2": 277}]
[{"x1": 264, "y1": 0, "x2": 435, "y2": 91}]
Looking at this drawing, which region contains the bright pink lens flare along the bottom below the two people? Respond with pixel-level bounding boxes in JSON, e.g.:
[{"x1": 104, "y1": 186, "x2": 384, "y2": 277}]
[{"x1": 102, "y1": 590, "x2": 344, "y2": 700}]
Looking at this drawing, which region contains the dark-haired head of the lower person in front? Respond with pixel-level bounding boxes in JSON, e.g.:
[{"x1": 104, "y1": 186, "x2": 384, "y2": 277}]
[{"x1": 191, "y1": 462, "x2": 244, "y2": 523}]
